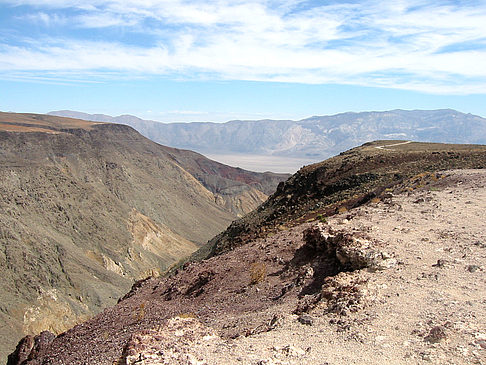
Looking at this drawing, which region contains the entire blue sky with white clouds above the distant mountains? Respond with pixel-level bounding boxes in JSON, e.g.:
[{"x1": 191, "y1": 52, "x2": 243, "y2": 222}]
[{"x1": 0, "y1": 0, "x2": 486, "y2": 122}]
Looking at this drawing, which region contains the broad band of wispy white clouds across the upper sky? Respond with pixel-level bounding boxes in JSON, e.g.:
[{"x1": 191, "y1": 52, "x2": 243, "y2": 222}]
[{"x1": 0, "y1": 0, "x2": 486, "y2": 94}]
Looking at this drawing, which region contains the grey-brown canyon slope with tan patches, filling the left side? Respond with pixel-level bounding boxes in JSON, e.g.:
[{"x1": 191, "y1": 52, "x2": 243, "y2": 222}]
[{"x1": 0, "y1": 113, "x2": 285, "y2": 362}]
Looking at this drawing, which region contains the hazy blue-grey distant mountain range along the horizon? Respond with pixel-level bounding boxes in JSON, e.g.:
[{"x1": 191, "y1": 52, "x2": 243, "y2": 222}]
[{"x1": 49, "y1": 109, "x2": 486, "y2": 166}]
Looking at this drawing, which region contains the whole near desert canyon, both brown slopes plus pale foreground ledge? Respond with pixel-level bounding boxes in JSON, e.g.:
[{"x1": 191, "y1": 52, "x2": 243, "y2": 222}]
[{"x1": 0, "y1": 113, "x2": 486, "y2": 365}]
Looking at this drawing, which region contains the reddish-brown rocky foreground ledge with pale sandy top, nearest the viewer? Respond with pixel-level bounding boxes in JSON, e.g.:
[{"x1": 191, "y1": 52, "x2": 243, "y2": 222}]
[{"x1": 9, "y1": 170, "x2": 486, "y2": 364}]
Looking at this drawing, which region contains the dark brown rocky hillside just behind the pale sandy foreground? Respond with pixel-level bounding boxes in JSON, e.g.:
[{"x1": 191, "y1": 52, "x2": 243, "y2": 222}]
[{"x1": 204, "y1": 141, "x2": 486, "y2": 257}]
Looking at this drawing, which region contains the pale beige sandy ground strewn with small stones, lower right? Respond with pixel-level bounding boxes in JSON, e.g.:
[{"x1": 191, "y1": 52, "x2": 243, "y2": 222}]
[{"x1": 139, "y1": 170, "x2": 486, "y2": 364}]
